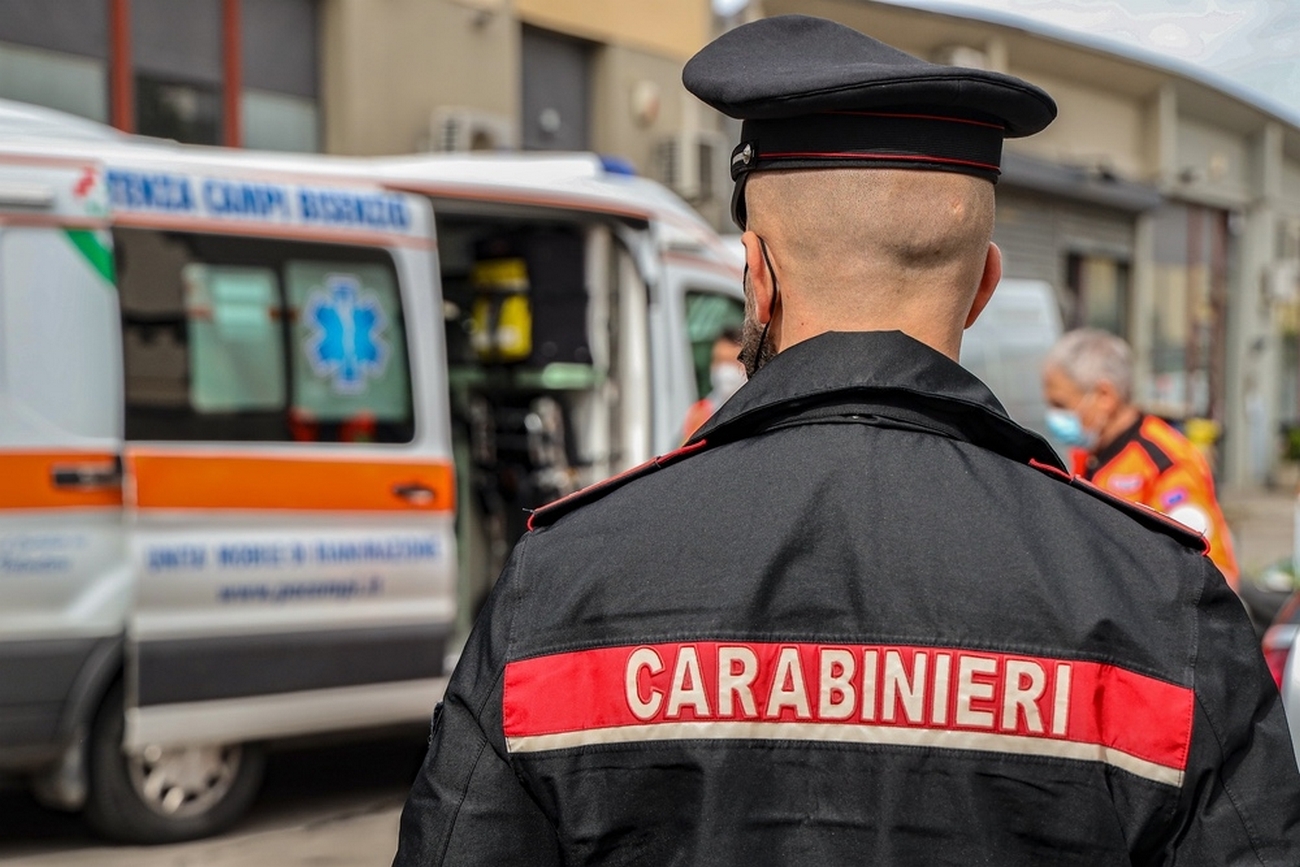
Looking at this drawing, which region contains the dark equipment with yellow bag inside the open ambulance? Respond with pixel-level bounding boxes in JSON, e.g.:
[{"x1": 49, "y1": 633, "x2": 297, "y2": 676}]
[{"x1": 436, "y1": 217, "x2": 595, "y2": 607}]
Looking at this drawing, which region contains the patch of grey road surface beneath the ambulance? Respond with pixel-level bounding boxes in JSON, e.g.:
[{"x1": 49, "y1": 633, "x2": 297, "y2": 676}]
[{"x1": 0, "y1": 734, "x2": 425, "y2": 867}]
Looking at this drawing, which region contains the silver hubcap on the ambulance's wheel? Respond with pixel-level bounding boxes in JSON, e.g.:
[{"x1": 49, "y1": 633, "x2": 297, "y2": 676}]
[{"x1": 127, "y1": 745, "x2": 243, "y2": 819}]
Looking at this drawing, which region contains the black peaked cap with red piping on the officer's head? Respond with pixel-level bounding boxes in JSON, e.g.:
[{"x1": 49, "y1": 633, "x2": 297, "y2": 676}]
[{"x1": 683, "y1": 16, "x2": 1056, "y2": 227}]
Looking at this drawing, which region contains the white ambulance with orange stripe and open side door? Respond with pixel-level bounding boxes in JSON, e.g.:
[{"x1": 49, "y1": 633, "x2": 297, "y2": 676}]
[{"x1": 0, "y1": 103, "x2": 744, "y2": 842}]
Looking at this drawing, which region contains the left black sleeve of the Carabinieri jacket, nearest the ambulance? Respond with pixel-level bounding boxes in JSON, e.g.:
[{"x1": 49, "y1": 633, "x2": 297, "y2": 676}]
[{"x1": 393, "y1": 537, "x2": 560, "y2": 867}]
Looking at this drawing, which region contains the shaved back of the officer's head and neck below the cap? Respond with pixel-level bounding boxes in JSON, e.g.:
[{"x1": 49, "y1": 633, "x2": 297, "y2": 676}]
[{"x1": 745, "y1": 169, "x2": 995, "y2": 353}]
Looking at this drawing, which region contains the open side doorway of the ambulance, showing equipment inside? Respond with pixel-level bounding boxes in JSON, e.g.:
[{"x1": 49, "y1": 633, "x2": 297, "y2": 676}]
[{"x1": 433, "y1": 205, "x2": 654, "y2": 634}]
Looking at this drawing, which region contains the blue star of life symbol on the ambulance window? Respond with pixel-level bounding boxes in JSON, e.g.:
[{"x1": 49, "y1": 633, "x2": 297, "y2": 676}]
[{"x1": 304, "y1": 274, "x2": 389, "y2": 394}]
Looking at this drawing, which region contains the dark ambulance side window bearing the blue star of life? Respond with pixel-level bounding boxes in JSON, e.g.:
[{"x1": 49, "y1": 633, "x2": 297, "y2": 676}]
[{"x1": 114, "y1": 230, "x2": 415, "y2": 442}]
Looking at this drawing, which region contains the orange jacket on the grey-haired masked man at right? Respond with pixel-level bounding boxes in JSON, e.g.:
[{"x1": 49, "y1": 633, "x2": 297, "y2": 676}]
[{"x1": 1076, "y1": 416, "x2": 1239, "y2": 589}]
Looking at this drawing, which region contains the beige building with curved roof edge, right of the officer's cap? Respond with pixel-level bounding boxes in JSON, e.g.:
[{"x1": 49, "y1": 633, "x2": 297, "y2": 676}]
[{"x1": 762, "y1": 0, "x2": 1300, "y2": 486}]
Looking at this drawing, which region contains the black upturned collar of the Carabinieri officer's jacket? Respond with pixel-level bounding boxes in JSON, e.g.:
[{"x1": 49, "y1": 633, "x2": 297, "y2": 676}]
[{"x1": 690, "y1": 331, "x2": 1063, "y2": 469}]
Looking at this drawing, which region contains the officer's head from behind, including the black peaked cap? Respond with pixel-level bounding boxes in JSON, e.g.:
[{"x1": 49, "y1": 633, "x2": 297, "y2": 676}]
[{"x1": 683, "y1": 16, "x2": 1056, "y2": 365}]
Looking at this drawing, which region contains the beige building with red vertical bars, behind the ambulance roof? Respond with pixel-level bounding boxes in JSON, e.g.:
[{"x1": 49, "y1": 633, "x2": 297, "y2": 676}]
[{"x1": 0, "y1": 0, "x2": 731, "y2": 224}]
